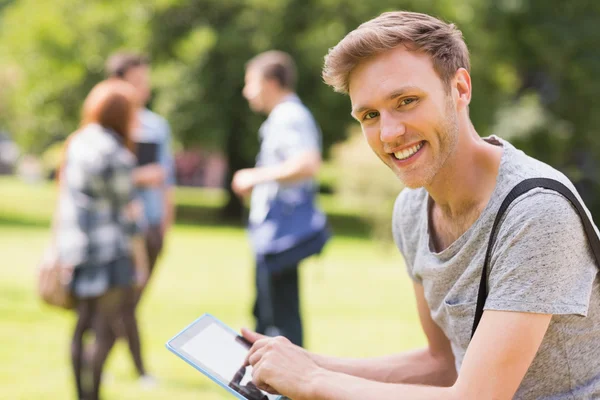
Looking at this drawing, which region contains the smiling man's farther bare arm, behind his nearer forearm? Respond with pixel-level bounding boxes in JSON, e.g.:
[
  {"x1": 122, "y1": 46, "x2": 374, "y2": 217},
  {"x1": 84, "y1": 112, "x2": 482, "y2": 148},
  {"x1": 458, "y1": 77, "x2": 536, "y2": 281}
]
[{"x1": 311, "y1": 283, "x2": 457, "y2": 386}]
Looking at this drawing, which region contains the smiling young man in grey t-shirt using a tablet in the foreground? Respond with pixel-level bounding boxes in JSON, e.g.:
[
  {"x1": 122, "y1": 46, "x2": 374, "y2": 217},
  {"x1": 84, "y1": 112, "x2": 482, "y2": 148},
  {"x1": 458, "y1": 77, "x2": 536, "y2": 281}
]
[{"x1": 239, "y1": 12, "x2": 600, "y2": 400}]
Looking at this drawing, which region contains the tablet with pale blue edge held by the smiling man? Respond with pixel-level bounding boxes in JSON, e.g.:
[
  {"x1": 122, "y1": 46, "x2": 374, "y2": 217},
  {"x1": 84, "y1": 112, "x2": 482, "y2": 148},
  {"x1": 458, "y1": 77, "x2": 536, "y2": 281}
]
[{"x1": 166, "y1": 314, "x2": 285, "y2": 400}]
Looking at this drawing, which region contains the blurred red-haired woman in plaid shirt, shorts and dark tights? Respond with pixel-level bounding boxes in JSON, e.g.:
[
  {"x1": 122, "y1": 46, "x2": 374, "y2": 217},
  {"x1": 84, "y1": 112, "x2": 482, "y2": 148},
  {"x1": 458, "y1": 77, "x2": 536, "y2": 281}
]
[{"x1": 55, "y1": 80, "x2": 149, "y2": 400}]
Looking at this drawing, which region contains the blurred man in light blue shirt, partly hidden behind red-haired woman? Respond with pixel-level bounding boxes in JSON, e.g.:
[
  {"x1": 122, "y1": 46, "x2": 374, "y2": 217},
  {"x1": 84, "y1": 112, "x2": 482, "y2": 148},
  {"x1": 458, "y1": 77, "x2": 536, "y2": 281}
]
[{"x1": 106, "y1": 52, "x2": 175, "y2": 386}]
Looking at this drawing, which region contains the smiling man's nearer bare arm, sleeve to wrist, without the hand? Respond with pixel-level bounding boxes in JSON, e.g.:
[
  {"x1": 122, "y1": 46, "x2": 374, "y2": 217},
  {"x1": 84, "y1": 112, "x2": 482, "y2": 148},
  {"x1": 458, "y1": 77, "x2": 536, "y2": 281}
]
[{"x1": 310, "y1": 311, "x2": 552, "y2": 400}]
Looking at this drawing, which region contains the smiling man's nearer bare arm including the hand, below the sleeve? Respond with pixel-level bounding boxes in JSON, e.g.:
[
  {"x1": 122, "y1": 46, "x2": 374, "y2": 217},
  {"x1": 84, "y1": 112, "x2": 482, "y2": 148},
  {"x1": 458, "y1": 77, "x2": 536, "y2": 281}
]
[{"x1": 248, "y1": 310, "x2": 552, "y2": 400}]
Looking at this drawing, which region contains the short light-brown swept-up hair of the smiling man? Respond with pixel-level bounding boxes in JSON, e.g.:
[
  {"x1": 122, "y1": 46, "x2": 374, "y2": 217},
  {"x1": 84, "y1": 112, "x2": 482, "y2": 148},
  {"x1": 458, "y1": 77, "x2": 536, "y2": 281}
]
[{"x1": 323, "y1": 11, "x2": 470, "y2": 93}]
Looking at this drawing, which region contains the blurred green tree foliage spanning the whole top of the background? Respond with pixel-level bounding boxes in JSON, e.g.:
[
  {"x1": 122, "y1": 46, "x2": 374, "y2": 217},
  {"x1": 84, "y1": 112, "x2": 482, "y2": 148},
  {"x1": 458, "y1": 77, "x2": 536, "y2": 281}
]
[{"x1": 0, "y1": 0, "x2": 600, "y2": 217}]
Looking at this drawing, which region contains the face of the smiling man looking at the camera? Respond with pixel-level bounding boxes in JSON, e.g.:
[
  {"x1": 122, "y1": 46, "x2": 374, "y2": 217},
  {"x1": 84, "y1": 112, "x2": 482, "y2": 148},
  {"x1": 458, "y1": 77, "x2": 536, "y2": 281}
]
[{"x1": 349, "y1": 46, "x2": 459, "y2": 188}]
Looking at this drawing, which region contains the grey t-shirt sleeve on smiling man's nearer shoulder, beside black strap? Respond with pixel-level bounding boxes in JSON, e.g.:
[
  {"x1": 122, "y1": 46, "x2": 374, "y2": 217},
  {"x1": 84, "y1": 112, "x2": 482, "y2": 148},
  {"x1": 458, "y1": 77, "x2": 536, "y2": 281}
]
[{"x1": 485, "y1": 189, "x2": 597, "y2": 316}]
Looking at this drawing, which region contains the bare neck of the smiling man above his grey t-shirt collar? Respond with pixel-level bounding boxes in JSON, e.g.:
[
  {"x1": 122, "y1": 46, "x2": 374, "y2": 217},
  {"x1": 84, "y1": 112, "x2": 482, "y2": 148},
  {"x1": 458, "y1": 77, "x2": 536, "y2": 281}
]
[{"x1": 425, "y1": 121, "x2": 502, "y2": 219}]
